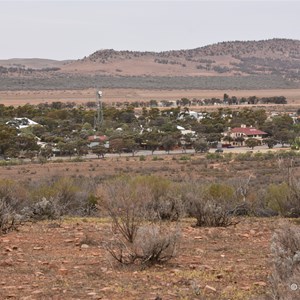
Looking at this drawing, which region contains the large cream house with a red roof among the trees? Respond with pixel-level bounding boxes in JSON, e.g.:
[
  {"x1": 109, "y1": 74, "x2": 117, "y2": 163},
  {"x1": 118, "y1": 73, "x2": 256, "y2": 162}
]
[{"x1": 223, "y1": 125, "x2": 268, "y2": 146}]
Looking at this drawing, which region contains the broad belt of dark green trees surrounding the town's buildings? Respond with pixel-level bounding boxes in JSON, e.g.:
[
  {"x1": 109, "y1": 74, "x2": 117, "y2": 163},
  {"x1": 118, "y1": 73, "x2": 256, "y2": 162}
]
[{"x1": 0, "y1": 102, "x2": 300, "y2": 158}]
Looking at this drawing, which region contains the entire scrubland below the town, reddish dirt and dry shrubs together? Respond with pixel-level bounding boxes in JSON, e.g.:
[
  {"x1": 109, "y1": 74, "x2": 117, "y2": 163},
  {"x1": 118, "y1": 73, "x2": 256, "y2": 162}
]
[{"x1": 0, "y1": 152, "x2": 300, "y2": 299}]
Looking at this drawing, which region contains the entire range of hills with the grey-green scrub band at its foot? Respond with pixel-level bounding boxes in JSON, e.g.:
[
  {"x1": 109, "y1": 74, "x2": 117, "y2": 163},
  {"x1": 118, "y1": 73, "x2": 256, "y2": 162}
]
[{"x1": 0, "y1": 39, "x2": 300, "y2": 90}]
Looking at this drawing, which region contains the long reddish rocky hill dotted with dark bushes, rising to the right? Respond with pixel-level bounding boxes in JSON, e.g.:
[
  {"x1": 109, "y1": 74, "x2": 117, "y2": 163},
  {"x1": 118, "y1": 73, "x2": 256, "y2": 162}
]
[{"x1": 63, "y1": 39, "x2": 300, "y2": 79}]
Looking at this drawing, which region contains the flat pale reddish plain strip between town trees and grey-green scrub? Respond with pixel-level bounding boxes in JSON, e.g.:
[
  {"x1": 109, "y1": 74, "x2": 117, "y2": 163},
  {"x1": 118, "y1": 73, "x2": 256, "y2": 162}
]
[{"x1": 0, "y1": 89, "x2": 300, "y2": 106}]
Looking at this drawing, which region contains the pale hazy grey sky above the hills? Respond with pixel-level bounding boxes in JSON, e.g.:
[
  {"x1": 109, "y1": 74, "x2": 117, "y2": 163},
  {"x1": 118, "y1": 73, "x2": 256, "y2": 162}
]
[{"x1": 0, "y1": 0, "x2": 300, "y2": 60}]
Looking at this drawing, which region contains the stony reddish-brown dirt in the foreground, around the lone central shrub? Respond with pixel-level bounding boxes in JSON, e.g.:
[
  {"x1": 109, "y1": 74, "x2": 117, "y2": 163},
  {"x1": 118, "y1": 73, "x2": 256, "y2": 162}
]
[{"x1": 0, "y1": 218, "x2": 279, "y2": 300}]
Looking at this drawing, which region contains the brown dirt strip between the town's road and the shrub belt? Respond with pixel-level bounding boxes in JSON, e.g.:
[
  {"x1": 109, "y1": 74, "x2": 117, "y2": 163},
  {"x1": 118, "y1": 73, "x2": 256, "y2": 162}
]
[{"x1": 0, "y1": 152, "x2": 300, "y2": 188}]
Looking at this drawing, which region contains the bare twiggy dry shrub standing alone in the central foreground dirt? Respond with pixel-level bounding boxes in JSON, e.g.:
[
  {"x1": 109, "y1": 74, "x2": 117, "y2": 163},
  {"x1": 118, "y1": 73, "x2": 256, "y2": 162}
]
[{"x1": 99, "y1": 177, "x2": 179, "y2": 265}]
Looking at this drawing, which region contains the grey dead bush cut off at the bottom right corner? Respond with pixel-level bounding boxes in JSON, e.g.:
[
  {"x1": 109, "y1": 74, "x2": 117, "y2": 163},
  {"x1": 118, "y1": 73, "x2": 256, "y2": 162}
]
[{"x1": 270, "y1": 223, "x2": 300, "y2": 300}]
